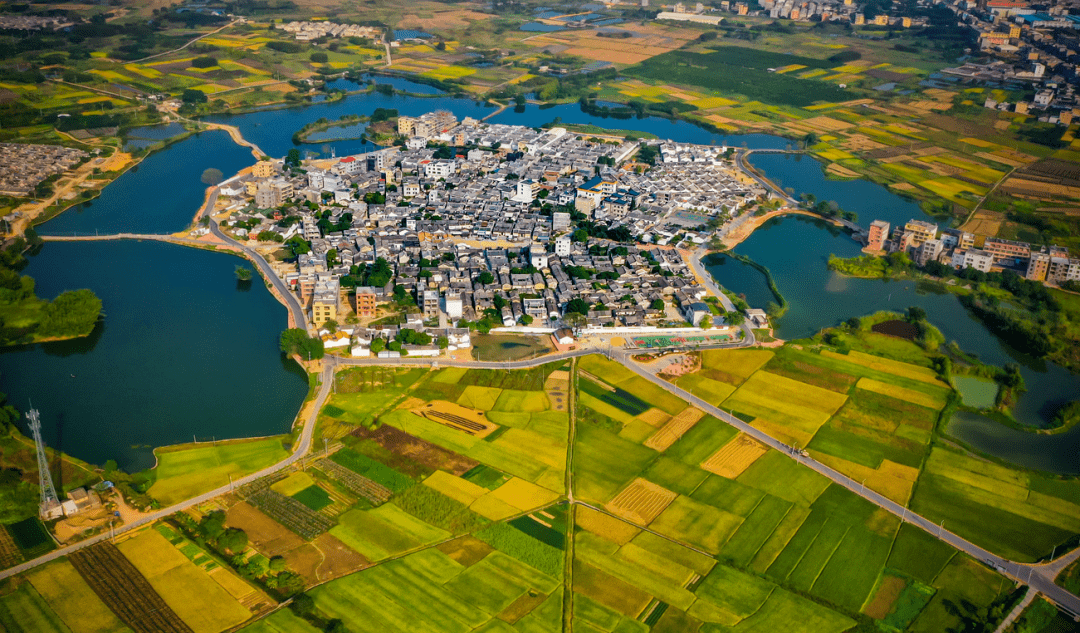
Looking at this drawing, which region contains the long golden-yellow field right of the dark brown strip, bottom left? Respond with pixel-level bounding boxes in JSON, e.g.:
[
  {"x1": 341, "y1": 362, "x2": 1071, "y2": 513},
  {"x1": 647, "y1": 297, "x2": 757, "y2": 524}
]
[{"x1": 117, "y1": 529, "x2": 252, "y2": 633}]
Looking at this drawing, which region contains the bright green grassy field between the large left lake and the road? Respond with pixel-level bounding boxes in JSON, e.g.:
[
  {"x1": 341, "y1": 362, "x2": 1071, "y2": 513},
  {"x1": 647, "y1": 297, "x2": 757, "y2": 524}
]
[{"x1": 148, "y1": 436, "x2": 288, "y2": 506}]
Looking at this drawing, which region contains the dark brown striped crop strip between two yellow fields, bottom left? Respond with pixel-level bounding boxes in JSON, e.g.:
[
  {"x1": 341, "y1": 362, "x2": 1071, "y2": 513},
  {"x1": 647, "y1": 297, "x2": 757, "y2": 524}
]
[{"x1": 69, "y1": 540, "x2": 192, "y2": 633}]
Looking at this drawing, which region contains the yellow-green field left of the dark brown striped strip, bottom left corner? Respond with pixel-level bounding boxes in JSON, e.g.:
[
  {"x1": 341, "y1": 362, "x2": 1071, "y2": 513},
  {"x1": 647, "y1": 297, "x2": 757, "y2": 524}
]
[{"x1": 26, "y1": 558, "x2": 124, "y2": 633}]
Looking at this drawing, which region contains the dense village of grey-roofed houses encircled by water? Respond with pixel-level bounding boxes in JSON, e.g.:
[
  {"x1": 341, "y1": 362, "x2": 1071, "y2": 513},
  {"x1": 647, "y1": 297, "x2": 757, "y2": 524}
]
[{"x1": 206, "y1": 112, "x2": 768, "y2": 356}]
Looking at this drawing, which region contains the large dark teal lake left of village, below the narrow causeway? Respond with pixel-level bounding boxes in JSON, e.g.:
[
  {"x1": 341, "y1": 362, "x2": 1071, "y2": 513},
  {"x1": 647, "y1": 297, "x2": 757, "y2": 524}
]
[{"x1": 0, "y1": 241, "x2": 308, "y2": 472}]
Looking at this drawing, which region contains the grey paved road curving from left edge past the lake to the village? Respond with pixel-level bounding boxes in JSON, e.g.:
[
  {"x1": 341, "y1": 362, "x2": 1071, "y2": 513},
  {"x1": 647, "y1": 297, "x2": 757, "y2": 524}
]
[{"x1": 0, "y1": 361, "x2": 334, "y2": 580}]
